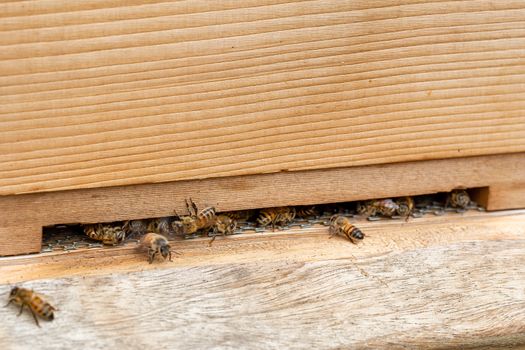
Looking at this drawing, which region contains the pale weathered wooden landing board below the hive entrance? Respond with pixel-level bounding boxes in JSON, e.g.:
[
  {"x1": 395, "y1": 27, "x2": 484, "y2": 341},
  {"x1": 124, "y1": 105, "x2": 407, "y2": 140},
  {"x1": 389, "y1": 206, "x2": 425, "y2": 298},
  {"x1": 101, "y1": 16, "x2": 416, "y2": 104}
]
[{"x1": 0, "y1": 211, "x2": 525, "y2": 350}]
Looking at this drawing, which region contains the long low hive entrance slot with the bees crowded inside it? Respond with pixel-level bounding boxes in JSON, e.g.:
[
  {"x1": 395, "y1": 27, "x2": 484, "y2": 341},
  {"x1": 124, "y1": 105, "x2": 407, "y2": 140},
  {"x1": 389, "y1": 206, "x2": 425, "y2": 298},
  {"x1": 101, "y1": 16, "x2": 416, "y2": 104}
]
[{"x1": 41, "y1": 189, "x2": 484, "y2": 253}]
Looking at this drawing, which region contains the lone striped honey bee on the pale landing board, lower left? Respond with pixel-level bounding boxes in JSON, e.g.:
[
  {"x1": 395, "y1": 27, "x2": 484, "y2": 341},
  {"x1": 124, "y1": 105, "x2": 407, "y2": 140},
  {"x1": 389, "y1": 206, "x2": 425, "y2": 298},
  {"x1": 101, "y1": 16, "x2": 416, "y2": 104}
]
[{"x1": 6, "y1": 287, "x2": 56, "y2": 327}]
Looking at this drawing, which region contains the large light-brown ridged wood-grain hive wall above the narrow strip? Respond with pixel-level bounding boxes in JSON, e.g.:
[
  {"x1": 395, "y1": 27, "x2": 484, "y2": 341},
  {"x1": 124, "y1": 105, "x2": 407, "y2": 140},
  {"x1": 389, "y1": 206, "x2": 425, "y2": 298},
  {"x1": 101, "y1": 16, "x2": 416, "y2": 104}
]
[{"x1": 0, "y1": 0, "x2": 525, "y2": 195}]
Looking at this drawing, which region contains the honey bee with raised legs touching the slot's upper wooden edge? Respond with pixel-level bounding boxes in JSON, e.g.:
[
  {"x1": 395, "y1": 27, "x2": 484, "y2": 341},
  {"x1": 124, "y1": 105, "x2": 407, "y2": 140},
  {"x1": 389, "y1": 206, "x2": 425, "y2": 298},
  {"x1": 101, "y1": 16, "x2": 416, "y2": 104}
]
[{"x1": 171, "y1": 198, "x2": 216, "y2": 235}]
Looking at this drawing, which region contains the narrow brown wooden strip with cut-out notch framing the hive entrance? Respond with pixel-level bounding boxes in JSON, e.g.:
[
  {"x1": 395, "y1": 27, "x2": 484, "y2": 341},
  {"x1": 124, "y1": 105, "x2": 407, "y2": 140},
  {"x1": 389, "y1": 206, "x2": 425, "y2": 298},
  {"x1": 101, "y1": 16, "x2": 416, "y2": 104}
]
[{"x1": 0, "y1": 153, "x2": 525, "y2": 255}]
